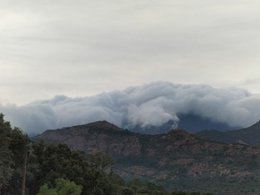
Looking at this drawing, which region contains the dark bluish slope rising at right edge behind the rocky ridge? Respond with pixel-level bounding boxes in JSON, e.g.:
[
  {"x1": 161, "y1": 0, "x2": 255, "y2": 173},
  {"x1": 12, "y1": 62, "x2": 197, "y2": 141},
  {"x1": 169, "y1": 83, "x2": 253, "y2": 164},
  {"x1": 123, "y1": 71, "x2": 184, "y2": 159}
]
[{"x1": 197, "y1": 121, "x2": 260, "y2": 146}]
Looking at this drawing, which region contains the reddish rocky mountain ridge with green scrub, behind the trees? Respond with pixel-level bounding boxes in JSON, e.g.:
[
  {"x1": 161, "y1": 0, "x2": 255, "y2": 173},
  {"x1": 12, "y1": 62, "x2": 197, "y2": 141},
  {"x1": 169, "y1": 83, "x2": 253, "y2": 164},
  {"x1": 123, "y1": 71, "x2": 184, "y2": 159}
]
[{"x1": 37, "y1": 121, "x2": 260, "y2": 195}]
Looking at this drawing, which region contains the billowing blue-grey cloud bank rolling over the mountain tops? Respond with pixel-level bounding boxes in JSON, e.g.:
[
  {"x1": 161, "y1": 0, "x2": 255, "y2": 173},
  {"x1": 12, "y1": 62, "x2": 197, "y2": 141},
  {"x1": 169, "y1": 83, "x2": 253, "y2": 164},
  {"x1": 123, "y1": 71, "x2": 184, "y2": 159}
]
[{"x1": 0, "y1": 82, "x2": 260, "y2": 134}]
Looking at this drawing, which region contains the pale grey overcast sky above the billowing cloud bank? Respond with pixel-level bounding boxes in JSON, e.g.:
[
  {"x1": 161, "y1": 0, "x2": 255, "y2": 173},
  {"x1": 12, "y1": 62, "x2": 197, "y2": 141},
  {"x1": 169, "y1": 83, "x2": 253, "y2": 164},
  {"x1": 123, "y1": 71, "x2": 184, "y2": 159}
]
[{"x1": 0, "y1": 0, "x2": 260, "y2": 105}]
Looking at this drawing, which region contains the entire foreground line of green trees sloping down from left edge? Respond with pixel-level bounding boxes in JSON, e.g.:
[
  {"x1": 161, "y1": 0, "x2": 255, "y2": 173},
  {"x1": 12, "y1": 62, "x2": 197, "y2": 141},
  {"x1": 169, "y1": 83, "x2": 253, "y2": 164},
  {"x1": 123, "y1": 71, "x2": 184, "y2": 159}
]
[{"x1": 0, "y1": 114, "x2": 211, "y2": 195}]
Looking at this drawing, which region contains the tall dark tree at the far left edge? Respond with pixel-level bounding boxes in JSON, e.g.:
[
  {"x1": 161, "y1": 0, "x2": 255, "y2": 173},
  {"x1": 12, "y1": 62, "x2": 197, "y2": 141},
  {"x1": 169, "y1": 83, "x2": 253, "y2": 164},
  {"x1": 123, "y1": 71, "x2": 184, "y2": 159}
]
[{"x1": 0, "y1": 114, "x2": 29, "y2": 194}]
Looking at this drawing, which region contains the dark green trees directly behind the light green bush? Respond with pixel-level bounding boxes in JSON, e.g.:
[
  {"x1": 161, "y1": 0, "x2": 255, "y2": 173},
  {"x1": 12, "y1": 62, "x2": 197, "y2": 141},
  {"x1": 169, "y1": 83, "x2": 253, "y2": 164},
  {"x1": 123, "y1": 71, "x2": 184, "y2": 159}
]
[{"x1": 28, "y1": 143, "x2": 118, "y2": 194}]
